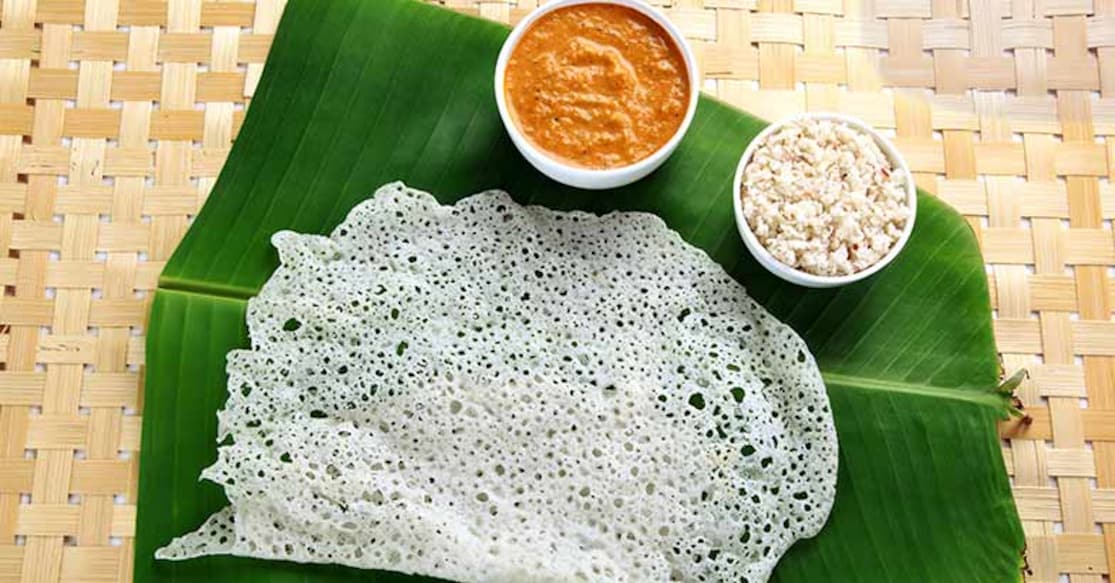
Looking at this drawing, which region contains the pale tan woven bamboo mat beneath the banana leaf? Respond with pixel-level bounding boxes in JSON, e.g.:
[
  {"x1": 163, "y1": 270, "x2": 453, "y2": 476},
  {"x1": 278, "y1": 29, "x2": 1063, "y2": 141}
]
[{"x1": 0, "y1": 0, "x2": 1115, "y2": 582}]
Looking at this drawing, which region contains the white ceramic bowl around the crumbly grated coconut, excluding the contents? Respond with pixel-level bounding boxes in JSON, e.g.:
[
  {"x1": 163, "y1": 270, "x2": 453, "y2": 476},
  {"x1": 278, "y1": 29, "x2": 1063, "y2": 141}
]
[{"x1": 731, "y1": 113, "x2": 918, "y2": 288}]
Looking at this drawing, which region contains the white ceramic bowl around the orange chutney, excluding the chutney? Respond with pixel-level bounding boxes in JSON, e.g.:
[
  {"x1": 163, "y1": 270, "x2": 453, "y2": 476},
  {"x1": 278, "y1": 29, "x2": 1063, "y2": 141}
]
[{"x1": 495, "y1": 0, "x2": 700, "y2": 190}]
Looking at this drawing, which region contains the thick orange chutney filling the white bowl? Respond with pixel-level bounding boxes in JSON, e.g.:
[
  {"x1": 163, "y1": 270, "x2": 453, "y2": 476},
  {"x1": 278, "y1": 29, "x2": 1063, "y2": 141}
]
[{"x1": 504, "y1": 3, "x2": 692, "y2": 168}]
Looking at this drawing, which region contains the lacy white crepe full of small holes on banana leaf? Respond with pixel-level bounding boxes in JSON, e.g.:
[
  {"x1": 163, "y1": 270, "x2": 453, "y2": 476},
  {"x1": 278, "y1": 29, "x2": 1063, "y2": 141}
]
[{"x1": 156, "y1": 183, "x2": 836, "y2": 582}]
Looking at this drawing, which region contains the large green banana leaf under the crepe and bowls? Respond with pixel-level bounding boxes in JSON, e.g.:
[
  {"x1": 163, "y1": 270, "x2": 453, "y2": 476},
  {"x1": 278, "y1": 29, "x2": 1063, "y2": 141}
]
[{"x1": 135, "y1": 0, "x2": 1024, "y2": 583}]
